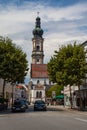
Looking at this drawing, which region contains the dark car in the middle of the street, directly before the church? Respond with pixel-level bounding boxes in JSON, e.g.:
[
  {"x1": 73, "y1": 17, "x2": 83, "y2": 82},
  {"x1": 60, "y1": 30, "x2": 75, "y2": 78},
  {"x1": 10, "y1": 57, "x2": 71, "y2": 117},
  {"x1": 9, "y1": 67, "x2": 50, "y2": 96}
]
[{"x1": 34, "y1": 100, "x2": 47, "y2": 111}]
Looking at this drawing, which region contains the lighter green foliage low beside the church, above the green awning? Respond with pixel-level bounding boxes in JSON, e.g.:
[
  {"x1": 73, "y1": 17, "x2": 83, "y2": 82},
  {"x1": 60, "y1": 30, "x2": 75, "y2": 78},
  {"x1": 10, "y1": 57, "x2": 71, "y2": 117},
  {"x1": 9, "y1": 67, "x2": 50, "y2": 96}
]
[{"x1": 46, "y1": 84, "x2": 63, "y2": 97}]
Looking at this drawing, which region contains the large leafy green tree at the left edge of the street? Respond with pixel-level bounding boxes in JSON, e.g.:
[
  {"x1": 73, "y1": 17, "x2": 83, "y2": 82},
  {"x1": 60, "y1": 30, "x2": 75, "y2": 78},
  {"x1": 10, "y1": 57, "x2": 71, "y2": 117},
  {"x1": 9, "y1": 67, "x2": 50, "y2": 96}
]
[{"x1": 0, "y1": 37, "x2": 28, "y2": 98}]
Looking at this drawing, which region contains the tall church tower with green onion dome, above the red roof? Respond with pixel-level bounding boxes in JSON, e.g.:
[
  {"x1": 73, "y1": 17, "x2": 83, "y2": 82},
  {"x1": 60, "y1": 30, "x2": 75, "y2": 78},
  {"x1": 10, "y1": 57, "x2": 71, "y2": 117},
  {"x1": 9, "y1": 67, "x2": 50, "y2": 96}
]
[{"x1": 31, "y1": 16, "x2": 44, "y2": 64}]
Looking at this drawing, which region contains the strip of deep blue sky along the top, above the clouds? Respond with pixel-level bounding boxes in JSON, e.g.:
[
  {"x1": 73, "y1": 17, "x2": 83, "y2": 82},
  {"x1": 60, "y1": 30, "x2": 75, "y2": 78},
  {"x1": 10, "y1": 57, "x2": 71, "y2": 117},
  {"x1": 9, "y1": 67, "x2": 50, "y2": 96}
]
[{"x1": 0, "y1": 0, "x2": 86, "y2": 6}]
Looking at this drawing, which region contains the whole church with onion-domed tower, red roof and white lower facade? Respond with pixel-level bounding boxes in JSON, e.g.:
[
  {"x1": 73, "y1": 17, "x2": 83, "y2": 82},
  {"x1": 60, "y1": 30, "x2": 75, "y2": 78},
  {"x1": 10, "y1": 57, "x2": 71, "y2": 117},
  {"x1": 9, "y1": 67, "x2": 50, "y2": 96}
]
[{"x1": 29, "y1": 16, "x2": 49, "y2": 103}]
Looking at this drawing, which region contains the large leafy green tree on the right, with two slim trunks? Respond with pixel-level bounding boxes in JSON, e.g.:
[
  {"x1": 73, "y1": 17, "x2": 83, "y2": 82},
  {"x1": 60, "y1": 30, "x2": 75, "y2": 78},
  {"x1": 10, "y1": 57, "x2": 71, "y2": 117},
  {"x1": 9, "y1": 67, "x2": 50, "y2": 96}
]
[{"x1": 48, "y1": 43, "x2": 87, "y2": 108}]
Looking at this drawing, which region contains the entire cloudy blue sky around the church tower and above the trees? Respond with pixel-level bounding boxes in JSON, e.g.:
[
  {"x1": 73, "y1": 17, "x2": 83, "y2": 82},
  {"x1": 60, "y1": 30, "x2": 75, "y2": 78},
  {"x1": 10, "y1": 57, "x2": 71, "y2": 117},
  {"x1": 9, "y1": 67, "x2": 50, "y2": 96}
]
[{"x1": 0, "y1": 0, "x2": 87, "y2": 83}]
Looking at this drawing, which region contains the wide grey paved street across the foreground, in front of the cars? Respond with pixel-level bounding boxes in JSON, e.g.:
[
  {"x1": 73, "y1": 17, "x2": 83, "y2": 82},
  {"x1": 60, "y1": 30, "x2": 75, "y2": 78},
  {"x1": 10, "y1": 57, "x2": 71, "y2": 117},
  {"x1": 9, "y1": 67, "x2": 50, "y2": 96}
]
[{"x1": 0, "y1": 106, "x2": 87, "y2": 130}]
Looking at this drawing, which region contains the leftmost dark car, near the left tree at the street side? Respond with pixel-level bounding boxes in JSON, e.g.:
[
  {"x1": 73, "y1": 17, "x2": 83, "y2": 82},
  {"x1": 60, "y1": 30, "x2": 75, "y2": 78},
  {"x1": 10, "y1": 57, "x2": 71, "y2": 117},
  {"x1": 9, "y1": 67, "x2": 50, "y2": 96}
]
[{"x1": 11, "y1": 100, "x2": 26, "y2": 112}]
